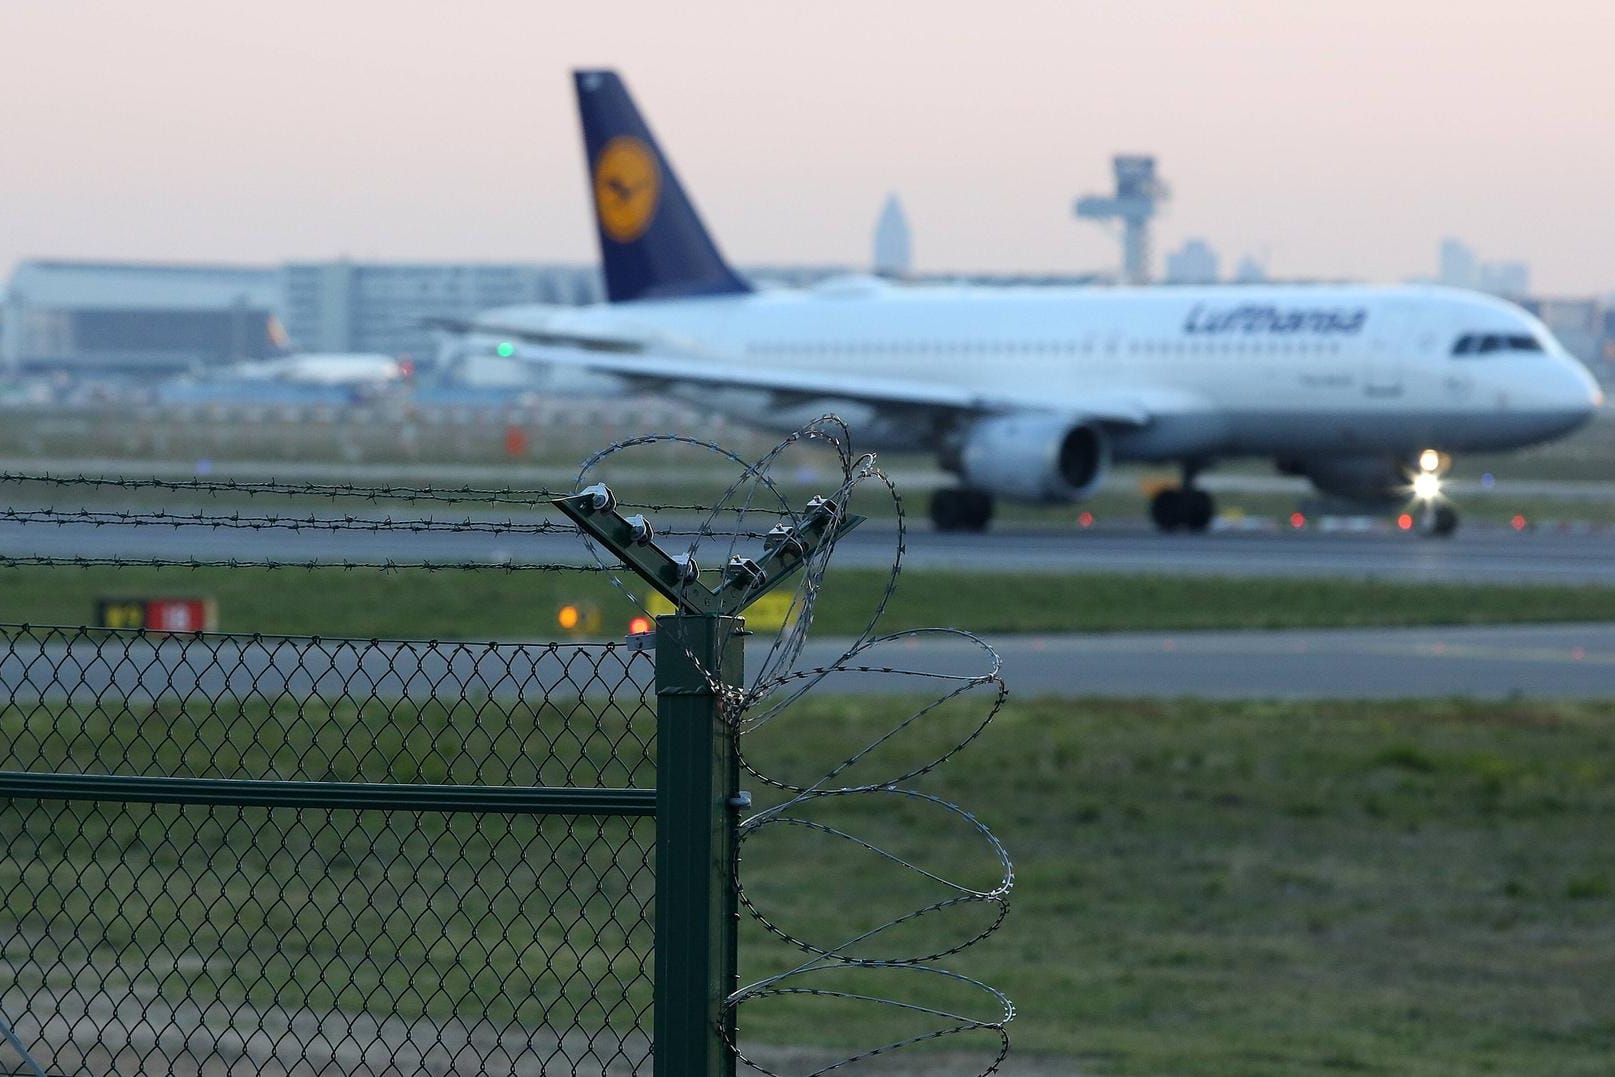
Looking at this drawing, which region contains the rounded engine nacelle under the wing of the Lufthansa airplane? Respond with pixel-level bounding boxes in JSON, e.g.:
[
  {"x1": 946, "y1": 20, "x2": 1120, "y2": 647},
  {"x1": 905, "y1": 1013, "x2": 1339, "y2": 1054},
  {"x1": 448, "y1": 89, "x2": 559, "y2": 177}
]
[{"x1": 958, "y1": 415, "x2": 1110, "y2": 502}]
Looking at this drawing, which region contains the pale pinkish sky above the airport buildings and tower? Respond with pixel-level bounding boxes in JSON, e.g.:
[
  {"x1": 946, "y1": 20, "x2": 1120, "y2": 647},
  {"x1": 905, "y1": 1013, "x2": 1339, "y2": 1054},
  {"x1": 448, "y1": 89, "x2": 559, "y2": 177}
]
[{"x1": 0, "y1": 0, "x2": 1615, "y2": 294}]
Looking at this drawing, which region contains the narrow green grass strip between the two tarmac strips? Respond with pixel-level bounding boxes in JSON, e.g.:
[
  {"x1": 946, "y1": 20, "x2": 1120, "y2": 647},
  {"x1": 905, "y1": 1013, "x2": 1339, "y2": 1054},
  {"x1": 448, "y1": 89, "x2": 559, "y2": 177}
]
[{"x1": 0, "y1": 567, "x2": 1615, "y2": 639}]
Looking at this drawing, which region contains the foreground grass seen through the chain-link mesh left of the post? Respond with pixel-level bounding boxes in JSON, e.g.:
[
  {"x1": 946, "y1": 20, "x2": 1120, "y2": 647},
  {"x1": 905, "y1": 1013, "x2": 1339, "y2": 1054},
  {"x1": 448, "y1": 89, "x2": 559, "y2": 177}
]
[{"x1": 0, "y1": 691, "x2": 654, "y2": 1074}]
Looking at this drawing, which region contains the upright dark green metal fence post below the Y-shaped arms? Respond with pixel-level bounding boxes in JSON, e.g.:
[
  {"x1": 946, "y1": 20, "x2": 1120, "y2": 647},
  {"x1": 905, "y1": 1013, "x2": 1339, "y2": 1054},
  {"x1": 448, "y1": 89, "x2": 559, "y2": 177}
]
[{"x1": 652, "y1": 614, "x2": 745, "y2": 1077}]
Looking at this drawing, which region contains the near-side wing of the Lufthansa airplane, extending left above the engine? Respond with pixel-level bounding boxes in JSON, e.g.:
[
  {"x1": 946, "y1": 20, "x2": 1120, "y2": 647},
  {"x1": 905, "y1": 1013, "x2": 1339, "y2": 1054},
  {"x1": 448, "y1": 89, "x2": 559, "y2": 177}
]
[{"x1": 470, "y1": 323, "x2": 1151, "y2": 426}]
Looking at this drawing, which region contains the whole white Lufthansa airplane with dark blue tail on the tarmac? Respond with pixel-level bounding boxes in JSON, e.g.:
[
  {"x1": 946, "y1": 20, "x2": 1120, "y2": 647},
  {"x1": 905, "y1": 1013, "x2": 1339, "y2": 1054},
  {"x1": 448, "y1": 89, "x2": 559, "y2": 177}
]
[{"x1": 460, "y1": 71, "x2": 1602, "y2": 533}]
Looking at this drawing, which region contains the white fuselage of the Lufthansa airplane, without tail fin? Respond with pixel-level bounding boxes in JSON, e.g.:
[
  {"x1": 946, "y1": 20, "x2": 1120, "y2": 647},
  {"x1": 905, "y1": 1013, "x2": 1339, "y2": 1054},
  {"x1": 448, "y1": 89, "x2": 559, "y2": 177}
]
[{"x1": 485, "y1": 278, "x2": 1602, "y2": 460}]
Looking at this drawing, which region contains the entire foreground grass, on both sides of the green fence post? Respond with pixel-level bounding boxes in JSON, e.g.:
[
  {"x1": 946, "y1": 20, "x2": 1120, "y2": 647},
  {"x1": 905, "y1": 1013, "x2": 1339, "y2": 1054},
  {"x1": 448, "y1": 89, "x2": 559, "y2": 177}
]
[{"x1": 0, "y1": 698, "x2": 1615, "y2": 1077}]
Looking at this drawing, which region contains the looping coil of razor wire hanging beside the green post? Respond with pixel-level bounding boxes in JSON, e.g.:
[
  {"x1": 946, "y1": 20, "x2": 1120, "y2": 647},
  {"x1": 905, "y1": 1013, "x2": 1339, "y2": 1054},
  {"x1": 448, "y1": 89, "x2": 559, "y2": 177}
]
[{"x1": 578, "y1": 417, "x2": 1014, "y2": 1077}]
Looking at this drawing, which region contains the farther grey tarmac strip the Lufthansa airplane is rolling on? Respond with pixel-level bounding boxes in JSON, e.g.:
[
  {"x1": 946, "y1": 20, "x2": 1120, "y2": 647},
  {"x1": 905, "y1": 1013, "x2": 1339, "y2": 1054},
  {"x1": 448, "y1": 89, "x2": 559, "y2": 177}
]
[{"x1": 0, "y1": 510, "x2": 1615, "y2": 586}]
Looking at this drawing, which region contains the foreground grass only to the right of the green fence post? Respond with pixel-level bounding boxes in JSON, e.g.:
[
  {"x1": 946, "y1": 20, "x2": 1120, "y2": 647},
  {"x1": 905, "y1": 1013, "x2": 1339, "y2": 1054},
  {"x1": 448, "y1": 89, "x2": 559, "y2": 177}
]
[{"x1": 743, "y1": 699, "x2": 1615, "y2": 1077}]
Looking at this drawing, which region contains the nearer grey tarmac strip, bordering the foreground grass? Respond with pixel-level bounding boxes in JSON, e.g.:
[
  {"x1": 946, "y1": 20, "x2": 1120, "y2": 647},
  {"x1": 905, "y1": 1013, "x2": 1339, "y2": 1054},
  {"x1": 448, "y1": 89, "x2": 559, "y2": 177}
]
[{"x1": 0, "y1": 625, "x2": 1615, "y2": 706}]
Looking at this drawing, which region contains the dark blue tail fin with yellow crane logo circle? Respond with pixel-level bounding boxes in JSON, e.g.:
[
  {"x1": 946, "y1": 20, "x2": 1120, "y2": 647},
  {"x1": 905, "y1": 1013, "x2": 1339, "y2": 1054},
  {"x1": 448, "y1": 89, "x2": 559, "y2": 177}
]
[{"x1": 572, "y1": 71, "x2": 751, "y2": 304}]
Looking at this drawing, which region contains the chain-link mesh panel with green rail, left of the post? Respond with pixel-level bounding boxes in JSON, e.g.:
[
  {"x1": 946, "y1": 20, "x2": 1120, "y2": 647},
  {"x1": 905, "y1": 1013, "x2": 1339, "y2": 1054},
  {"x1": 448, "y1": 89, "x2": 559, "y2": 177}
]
[{"x1": 0, "y1": 625, "x2": 656, "y2": 1077}]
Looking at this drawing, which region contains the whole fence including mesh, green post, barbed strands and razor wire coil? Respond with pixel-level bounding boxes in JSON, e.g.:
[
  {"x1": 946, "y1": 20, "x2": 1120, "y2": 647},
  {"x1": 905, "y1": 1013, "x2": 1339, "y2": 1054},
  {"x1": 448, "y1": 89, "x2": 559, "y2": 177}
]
[{"x1": 0, "y1": 417, "x2": 1014, "y2": 1077}]
